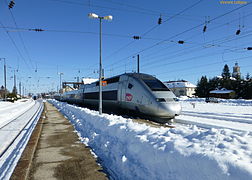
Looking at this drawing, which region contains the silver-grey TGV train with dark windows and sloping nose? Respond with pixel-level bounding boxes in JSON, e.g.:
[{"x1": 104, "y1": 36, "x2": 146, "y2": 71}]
[{"x1": 61, "y1": 73, "x2": 181, "y2": 123}]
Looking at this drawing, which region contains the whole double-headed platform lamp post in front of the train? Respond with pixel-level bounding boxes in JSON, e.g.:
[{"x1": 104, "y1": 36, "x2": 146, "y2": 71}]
[{"x1": 88, "y1": 13, "x2": 113, "y2": 115}]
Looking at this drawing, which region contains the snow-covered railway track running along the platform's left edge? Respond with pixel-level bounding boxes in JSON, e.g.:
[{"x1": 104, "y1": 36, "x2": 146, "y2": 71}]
[{"x1": 0, "y1": 101, "x2": 44, "y2": 179}]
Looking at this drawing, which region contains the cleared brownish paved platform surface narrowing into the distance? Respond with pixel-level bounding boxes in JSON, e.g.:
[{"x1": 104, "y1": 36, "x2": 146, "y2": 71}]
[{"x1": 11, "y1": 102, "x2": 108, "y2": 180}]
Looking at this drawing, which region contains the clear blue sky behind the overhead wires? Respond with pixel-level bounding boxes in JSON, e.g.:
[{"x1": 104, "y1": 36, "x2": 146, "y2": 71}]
[{"x1": 0, "y1": 0, "x2": 252, "y2": 92}]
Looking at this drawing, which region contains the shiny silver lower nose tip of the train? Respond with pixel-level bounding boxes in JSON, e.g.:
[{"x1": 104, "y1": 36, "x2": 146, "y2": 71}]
[{"x1": 158, "y1": 102, "x2": 182, "y2": 118}]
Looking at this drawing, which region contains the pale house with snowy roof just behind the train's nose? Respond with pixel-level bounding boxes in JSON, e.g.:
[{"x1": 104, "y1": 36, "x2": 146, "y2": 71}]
[{"x1": 163, "y1": 80, "x2": 196, "y2": 97}]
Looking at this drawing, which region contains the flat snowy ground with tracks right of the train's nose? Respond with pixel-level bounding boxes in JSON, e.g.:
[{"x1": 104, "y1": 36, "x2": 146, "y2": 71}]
[{"x1": 176, "y1": 99, "x2": 252, "y2": 131}]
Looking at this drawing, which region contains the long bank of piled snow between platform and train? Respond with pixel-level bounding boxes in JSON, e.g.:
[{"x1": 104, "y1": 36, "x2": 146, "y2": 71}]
[{"x1": 50, "y1": 100, "x2": 252, "y2": 180}]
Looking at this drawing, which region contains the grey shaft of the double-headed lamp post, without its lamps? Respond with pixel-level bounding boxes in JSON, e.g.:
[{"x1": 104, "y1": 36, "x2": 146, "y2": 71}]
[{"x1": 99, "y1": 17, "x2": 102, "y2": 115}]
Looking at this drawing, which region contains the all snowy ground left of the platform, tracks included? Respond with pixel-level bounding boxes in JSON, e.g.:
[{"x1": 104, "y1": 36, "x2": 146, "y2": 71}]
[{"x1": 0, "y1": 99, "x2": 43, "y2": 180}]
